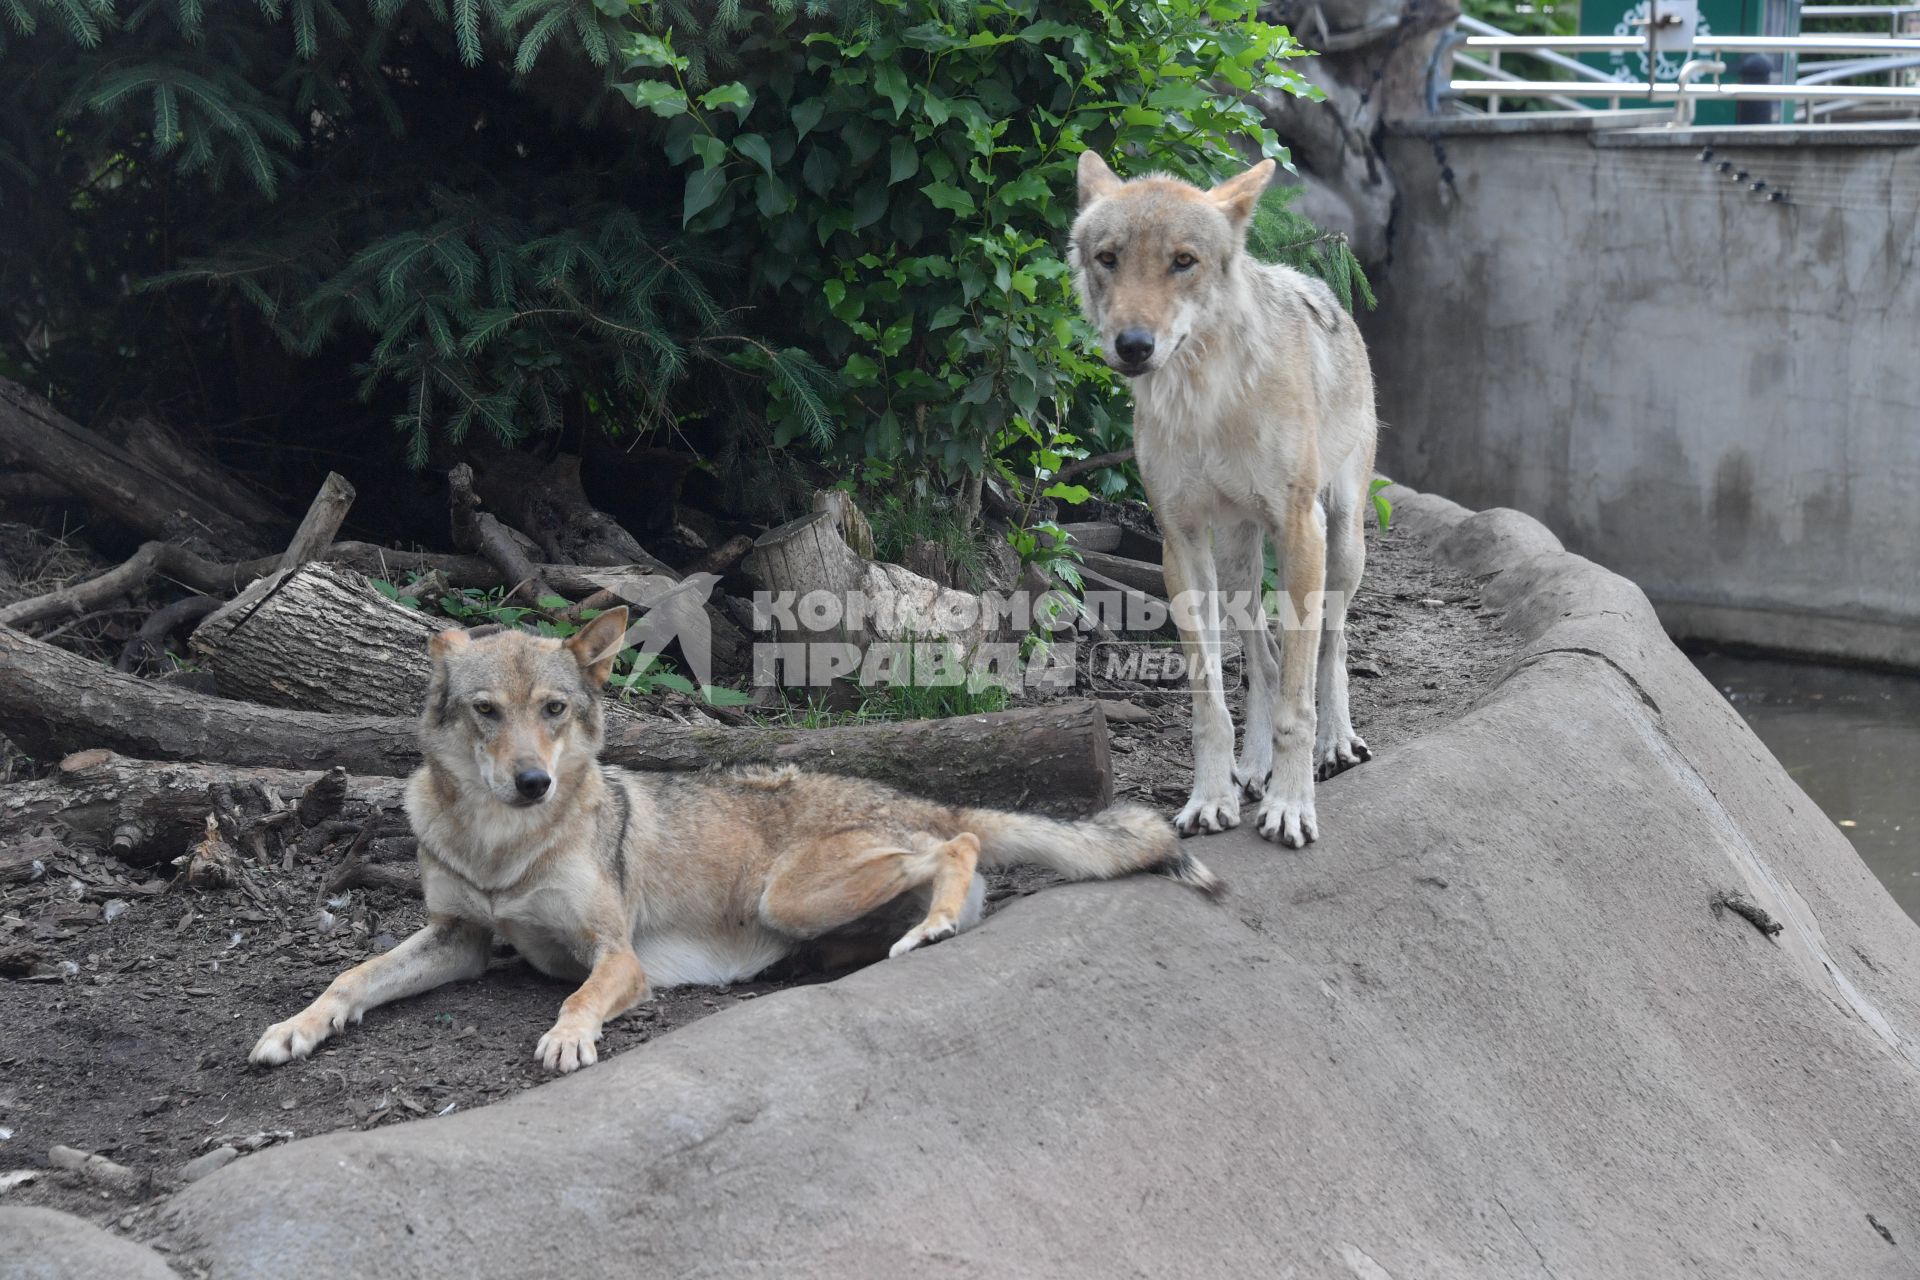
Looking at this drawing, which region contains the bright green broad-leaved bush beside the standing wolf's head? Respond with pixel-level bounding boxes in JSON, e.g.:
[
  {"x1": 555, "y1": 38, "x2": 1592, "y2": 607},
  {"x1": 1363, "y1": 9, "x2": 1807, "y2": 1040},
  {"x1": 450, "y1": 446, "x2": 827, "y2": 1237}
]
[{"x1": 620, "y1": 0, "x2": 1315, "y2": 482}]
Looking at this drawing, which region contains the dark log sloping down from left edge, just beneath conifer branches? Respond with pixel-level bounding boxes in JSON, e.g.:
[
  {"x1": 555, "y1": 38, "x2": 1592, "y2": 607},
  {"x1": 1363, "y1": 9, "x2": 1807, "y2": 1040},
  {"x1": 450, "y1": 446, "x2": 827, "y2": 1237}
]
[{"x1": 0, "y1": 378, "x2": 263, "y2": 555}]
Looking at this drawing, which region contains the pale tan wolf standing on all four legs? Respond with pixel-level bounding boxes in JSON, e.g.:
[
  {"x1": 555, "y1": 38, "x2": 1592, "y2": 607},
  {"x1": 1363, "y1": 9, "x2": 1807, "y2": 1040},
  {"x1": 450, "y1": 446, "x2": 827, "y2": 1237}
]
[{"x1": 1069, "y1": 152, "x2": 1377, "y2": 848}]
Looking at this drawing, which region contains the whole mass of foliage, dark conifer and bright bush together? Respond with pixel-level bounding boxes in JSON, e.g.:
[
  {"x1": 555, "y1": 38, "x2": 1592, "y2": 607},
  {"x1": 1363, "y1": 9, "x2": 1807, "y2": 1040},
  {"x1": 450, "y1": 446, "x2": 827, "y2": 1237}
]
[{"x1": 0, "y1": 0, "x2": 1365, "y2": 530}]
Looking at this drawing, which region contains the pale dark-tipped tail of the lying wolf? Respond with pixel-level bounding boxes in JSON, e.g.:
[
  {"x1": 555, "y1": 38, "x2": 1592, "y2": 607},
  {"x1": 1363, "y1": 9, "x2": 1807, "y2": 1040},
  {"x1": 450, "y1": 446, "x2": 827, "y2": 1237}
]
[{"x1": 960, "y1": 804, "x2": 1225, "y2": 898}]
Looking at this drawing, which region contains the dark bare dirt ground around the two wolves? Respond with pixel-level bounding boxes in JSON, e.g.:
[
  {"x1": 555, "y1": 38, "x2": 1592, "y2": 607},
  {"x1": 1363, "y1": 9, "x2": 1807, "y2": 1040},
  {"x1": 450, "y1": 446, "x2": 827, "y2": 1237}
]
[{"x1": 0, "y1": 521, "x2": 1513, "y2": 1228}]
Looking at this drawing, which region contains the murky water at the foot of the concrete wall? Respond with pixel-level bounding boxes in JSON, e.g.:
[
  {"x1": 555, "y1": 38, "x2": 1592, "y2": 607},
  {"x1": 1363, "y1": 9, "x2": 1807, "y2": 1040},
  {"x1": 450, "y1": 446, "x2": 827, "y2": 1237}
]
[{"x1": 1693, "y1": 652, "x2": 1920, "y2": 919}]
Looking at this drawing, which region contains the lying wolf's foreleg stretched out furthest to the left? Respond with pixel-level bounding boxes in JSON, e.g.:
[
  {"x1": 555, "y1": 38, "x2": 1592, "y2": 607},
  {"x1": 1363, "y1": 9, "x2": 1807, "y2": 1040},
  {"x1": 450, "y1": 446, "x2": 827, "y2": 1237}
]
[{"x1": 248, "y1": 917, "x2": 493, "y2": 1067}]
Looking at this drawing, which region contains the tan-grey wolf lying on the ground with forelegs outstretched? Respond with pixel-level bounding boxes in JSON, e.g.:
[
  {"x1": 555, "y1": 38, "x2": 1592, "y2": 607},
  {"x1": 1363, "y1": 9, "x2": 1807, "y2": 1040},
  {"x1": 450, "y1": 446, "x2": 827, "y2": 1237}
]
[{"x1": 252, "y1": 608, "x2": 1219, "y2": 1071}]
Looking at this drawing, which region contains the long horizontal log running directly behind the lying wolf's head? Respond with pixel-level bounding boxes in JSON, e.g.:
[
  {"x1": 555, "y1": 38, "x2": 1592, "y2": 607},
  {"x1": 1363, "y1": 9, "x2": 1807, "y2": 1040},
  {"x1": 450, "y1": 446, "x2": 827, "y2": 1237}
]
[{"x1": 0, "y1": 628, "x2": 1114, "y2": 814}]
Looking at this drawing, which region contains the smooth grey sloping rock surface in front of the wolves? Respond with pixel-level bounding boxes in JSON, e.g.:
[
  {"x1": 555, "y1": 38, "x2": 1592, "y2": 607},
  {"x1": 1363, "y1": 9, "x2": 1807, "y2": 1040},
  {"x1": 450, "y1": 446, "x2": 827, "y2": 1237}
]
[{"x1": 15, "y1": 489, "x2": 1920, "y2": 1280}]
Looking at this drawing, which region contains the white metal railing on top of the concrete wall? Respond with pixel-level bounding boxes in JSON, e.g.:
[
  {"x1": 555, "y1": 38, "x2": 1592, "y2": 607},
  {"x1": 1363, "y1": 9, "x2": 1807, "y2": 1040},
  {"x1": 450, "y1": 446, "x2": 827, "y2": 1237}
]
[{"x1": 1428, "y1": 4, "x2": 1920, "y2": 123}]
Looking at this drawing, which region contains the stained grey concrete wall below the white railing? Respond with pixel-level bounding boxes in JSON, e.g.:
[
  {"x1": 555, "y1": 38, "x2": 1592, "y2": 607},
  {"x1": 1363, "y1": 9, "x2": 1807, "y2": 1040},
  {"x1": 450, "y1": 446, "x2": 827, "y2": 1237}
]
[{"x1": 1369, "y1": 117, "x2": 1920, "y2": 666}]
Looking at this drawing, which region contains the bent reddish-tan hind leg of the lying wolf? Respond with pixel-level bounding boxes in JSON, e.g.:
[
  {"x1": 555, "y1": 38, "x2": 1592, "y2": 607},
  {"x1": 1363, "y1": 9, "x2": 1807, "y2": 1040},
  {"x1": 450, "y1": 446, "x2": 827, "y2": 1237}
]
[{"x1": 760, "y1": 831, "x2": 979, "y2": 954}]
